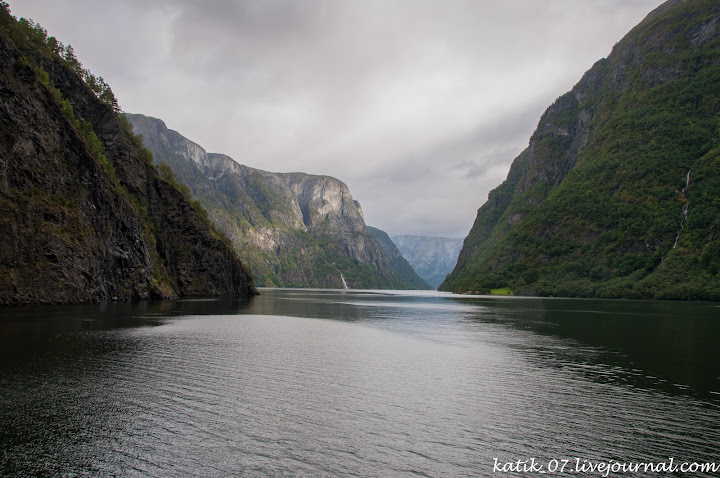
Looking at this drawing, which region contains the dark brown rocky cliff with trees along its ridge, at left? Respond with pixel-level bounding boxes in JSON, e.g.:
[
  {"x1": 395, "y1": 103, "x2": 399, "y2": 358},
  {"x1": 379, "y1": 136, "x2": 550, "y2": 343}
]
[{"x1": 0, "y1": 8, "x2": 254, "y2": 304}]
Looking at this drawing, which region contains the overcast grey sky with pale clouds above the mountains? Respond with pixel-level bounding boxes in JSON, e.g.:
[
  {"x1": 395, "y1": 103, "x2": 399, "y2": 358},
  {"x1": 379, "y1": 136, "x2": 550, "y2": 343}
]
[{"x1": 9, "y1": 0, "x2": 661, "y2": 237}]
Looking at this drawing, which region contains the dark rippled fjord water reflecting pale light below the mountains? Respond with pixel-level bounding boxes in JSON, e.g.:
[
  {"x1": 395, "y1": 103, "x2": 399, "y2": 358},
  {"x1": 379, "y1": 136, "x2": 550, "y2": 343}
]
[{"x1": 0, "y1": 290, "x2": 720, "y2": 477}]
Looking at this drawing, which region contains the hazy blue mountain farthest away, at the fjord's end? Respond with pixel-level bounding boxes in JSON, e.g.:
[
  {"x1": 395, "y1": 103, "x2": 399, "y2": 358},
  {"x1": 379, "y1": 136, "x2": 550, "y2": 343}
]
[{"x1": 392, "y1": 235, "x2": 463, "y2": 289}]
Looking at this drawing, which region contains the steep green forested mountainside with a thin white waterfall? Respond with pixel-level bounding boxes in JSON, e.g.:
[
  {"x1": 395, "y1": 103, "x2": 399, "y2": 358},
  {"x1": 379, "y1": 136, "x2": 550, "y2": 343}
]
[{"x1": 441, "y1": 0, "x2": 720, "y2": 300}]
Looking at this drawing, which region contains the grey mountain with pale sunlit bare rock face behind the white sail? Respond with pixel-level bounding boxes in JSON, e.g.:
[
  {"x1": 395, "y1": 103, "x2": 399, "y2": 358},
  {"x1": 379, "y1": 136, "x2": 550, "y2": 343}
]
[{"x1": 126, "y1": 114, "x2": 424, "y2": 289}]
